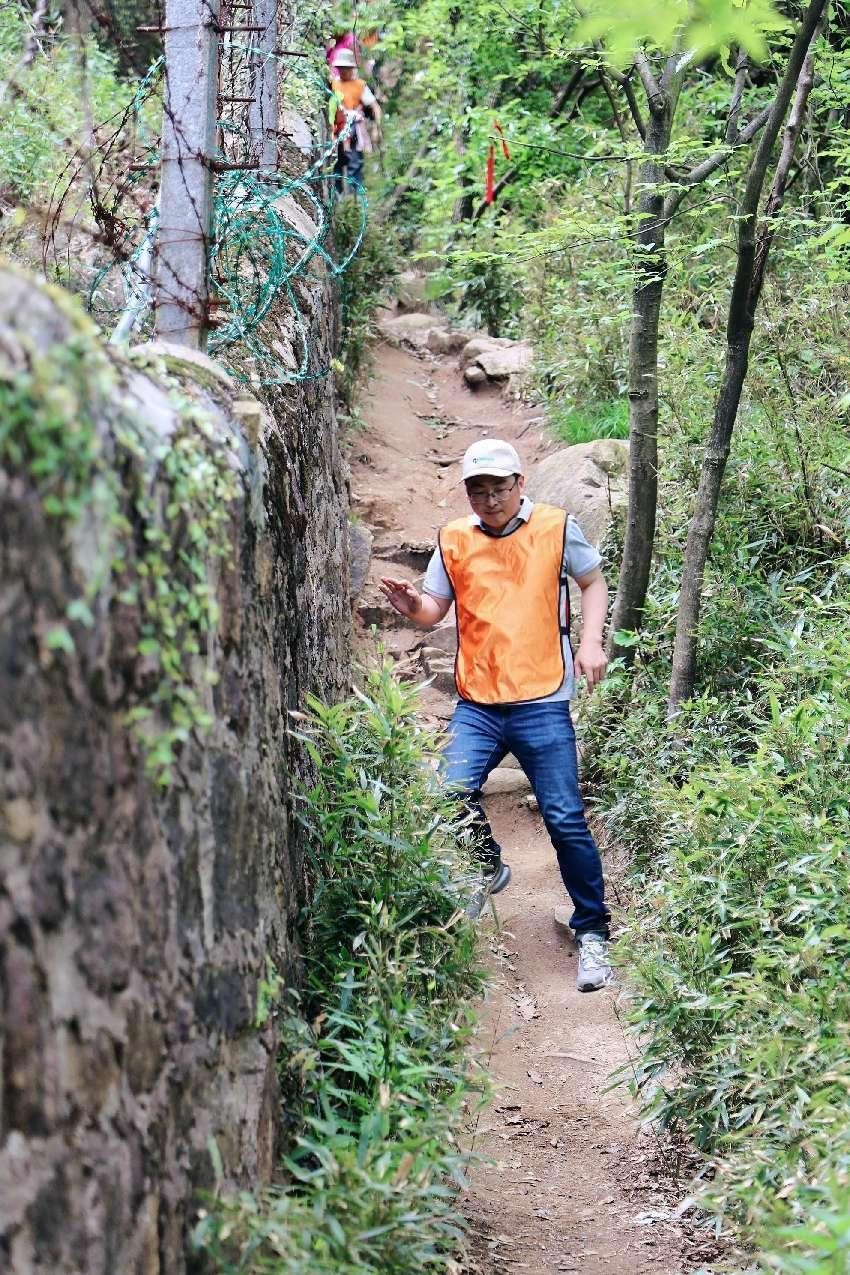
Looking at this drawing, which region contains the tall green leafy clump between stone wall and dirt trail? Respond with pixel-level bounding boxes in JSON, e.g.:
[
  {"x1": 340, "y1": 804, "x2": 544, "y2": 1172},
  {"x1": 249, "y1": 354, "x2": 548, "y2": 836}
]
[{"x1": 195, "y1": 667, "x2": 483, "y2": 1275}]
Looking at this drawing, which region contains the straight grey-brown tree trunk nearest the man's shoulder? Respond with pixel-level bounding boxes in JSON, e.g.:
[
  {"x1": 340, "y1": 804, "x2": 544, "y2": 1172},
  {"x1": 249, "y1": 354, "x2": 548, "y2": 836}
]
[{"x1": 612, "y1": 64, "x2": 681, "y2": 660}]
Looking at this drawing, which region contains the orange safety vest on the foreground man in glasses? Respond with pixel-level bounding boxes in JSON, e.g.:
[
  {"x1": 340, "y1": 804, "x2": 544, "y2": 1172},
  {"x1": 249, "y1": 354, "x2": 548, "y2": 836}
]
[{"x1": 440, "y1": 505, "x2": 570, "y2": 704}]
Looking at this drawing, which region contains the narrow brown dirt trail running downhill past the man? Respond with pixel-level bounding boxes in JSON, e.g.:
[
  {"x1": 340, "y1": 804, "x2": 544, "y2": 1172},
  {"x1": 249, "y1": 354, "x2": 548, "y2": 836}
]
[{"x1": 352, "y1": 347, "x2": 706, "y2": 1275}]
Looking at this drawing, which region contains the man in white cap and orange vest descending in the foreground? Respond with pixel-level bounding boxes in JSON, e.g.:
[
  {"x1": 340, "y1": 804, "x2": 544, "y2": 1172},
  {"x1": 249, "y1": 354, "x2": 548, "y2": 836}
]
[{"x1": 380, "y1": 439, "x2": 610, "y2": 992}]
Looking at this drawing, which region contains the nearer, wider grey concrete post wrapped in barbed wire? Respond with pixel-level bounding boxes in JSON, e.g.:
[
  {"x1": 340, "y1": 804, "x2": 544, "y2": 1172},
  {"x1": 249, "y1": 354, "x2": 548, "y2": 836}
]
[{"x1": 155, "y1": 0, "x2": 220, "y2": 349}]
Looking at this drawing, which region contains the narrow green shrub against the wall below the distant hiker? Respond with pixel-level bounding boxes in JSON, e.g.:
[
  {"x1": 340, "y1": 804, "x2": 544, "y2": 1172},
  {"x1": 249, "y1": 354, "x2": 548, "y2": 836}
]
[{"x1": 334, "y1": 199, "x2": 399, "y2": 411}]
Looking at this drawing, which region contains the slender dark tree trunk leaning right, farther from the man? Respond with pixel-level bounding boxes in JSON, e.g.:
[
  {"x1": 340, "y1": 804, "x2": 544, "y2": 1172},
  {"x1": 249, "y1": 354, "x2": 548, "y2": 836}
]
[{"x1": 668, "y1": 0, "x2": 828, "y2": 717}]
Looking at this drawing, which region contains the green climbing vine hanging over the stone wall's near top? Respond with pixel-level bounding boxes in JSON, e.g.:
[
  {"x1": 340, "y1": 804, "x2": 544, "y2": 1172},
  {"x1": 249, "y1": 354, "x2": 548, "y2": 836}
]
[{"x1": 0, "y1": 290, "x2": 238, "y2": 785}]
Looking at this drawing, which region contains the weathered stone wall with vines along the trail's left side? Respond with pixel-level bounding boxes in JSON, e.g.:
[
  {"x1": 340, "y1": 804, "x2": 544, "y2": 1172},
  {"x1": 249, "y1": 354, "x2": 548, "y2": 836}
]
[{"x1": 0, "y1": 258, "x2": 349, "y2": 1275}]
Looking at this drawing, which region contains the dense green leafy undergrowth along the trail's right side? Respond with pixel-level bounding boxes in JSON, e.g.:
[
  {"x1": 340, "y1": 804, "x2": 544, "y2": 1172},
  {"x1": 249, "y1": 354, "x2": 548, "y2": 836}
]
[{"x1": 586, "y1": 341, "x2": 850, "y2": 1272}]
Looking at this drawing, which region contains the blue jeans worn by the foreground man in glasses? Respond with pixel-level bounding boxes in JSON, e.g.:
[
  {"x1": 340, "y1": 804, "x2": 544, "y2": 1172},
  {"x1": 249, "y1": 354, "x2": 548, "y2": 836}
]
[{"x1": 442, "y1": 700, "x2": 609, "y2": 935}]
